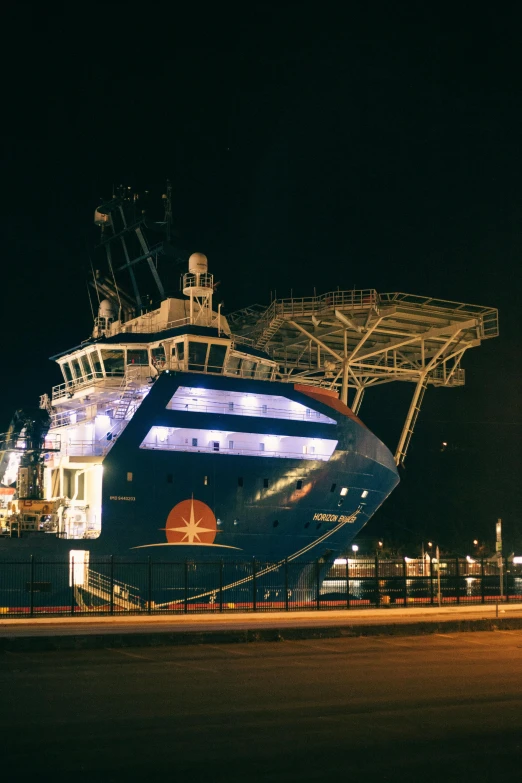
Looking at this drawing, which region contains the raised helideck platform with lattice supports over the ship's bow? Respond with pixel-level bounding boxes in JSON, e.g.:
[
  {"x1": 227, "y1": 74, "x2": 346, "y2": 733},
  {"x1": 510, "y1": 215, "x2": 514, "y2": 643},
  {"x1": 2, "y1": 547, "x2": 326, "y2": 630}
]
[{"x1": 228, "y1": 288, "x2": 498, "y2": 463}]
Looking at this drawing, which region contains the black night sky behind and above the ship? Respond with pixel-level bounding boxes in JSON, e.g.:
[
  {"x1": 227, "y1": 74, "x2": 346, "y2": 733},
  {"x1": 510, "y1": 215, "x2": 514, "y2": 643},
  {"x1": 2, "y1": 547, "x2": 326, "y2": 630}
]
[{"x1": 0, "y1": 2, "x2": 522, "y2": 554}]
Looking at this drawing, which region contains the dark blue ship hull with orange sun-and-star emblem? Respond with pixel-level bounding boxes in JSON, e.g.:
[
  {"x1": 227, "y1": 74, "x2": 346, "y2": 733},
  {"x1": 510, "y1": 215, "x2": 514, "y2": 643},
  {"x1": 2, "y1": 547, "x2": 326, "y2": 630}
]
[{"x1": 0, "y1": 373, "x2": 399, "y2": 563}]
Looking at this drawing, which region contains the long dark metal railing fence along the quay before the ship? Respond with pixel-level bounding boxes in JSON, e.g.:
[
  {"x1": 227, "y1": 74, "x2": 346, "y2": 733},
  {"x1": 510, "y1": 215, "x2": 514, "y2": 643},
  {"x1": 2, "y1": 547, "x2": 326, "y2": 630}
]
[{"x1": 0, "y1": 557, "x2": 522, "y2": 617}]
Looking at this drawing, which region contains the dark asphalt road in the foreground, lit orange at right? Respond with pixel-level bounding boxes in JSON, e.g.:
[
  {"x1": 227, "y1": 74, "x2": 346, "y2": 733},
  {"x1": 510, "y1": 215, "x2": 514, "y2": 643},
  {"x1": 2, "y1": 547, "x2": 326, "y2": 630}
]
[{"x1": 0, "y1": 631, "x2": 522, "y2": 783}]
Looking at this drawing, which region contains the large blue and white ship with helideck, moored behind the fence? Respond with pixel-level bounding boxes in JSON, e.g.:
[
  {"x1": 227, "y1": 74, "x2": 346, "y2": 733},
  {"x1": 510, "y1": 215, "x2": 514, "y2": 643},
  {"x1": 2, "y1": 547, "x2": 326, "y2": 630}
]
[{"x1": 0, "y1": 191, "x2": 498, "y2": 608}]
